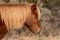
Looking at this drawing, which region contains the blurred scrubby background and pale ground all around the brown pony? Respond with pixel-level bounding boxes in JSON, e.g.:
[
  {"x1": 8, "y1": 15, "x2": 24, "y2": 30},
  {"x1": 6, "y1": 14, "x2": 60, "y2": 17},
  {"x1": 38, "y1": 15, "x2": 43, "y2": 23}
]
[{"x1": 0, "y1": 0, "x2": 60, "y2": 40}]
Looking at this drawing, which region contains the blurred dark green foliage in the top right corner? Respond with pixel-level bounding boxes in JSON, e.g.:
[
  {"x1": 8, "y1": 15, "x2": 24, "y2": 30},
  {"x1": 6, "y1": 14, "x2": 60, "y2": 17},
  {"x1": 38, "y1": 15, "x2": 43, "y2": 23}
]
[{"x1": 42, "y1": 0, "x2": 60, "y2": 15}]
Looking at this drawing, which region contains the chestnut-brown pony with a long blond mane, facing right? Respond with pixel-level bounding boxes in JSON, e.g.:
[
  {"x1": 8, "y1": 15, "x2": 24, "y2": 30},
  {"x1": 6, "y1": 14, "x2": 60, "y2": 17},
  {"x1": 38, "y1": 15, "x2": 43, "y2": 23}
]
[{"x1": 0, "y1": 4, "x2": 41, "y2": 39}]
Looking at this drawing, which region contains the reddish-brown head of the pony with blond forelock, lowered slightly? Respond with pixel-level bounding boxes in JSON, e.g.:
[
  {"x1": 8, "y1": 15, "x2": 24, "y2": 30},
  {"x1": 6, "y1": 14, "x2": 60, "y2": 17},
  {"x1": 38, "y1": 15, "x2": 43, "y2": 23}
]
[{"x1": 25, "y1": 4, "x2": 41, "y2": 33}]
